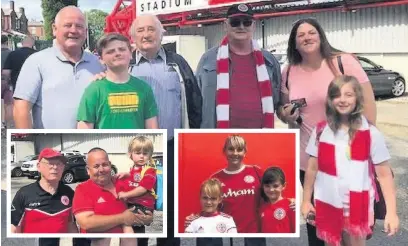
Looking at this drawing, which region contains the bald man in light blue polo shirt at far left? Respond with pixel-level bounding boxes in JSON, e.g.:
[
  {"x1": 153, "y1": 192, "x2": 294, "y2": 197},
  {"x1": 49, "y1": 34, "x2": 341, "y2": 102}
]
[{"x1": 14, "y1": 6, "x2": 104, "y2": 129}]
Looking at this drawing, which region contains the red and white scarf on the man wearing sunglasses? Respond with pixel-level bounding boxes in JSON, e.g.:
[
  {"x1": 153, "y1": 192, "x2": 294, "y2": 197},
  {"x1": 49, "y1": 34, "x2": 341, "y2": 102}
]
[{"x1": 216, "y1": 37, "x2": 274, "y2": 128}]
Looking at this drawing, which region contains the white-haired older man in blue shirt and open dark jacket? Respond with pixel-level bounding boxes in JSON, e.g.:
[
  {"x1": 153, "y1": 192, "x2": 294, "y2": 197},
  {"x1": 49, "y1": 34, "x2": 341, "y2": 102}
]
[{"x1": 130, "y1": 15, "x2": 202, "y2": 246}]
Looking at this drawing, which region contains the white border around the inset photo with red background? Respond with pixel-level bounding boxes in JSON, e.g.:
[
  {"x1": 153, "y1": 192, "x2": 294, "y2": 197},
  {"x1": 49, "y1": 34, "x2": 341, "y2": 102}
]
[{"x1": 174, "y1": 129, "x2": 301, "y2": 238}]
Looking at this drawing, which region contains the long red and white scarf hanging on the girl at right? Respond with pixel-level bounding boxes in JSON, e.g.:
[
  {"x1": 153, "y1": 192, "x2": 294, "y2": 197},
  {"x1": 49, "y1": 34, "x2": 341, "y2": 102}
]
[{"x1": 314, "y1": 117, "x2": 373, "y2": 245}]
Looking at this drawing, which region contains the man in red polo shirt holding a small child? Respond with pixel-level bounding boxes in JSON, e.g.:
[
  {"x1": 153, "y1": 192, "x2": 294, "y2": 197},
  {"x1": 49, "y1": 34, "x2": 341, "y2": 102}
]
[{"x1": 73, "y1": 148, "x2": 153, "y2": 233}]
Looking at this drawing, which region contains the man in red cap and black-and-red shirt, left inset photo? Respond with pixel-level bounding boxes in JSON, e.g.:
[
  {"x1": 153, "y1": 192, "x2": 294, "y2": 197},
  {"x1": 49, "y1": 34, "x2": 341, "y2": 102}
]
[{"x1": 11, "y1": 148, "x2": 78, "y2": 233}]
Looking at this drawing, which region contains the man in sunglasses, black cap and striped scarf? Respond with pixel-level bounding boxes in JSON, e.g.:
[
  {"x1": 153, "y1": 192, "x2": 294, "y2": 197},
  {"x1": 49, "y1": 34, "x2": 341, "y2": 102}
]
[{"x1": 196, "y1": 4, "x2": 281, "y2": 131}]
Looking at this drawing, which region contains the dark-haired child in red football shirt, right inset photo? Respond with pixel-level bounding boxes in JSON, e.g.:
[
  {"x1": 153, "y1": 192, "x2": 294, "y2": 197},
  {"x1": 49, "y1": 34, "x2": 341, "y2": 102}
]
[{"x1": 260, "y1": 167, "x2": 296, "y2": 233}]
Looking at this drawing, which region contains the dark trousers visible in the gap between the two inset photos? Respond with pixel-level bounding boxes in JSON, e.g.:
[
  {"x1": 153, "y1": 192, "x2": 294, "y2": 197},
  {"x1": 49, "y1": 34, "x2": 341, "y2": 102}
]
[{"x1": 157, "y1": 139, "x2": 180, "y2": 246}]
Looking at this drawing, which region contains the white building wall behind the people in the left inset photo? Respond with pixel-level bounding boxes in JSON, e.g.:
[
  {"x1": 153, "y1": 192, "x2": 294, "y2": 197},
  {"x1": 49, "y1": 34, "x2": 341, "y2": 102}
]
[{"x1": 34, "y1": 134, "x2": 165, "y2": 172}]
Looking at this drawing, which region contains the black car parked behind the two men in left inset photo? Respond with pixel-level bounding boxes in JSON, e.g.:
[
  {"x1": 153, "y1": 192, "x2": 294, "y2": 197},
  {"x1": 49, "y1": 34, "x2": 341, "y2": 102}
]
[{"x1": 62, "y1": 155, "x2": 118, "y2": 184}]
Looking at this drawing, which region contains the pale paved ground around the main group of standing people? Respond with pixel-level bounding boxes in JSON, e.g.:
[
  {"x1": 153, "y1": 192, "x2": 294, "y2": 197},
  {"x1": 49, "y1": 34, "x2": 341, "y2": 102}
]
[{"x1": 1, "y1": 95, "x2": 408, "y2": 246}]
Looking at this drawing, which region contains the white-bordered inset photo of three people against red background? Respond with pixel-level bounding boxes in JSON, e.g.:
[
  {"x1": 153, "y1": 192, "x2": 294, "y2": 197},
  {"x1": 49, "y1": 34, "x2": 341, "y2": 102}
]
[{"x1": 175, "y1": 129, "x2": 300, "y2": 240}]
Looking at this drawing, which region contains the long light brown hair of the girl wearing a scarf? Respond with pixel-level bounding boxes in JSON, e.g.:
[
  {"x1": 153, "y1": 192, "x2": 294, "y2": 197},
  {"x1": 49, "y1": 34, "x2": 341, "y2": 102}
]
[{"x1": 326, "y1": 75, "x2": 364, "y2": 139}]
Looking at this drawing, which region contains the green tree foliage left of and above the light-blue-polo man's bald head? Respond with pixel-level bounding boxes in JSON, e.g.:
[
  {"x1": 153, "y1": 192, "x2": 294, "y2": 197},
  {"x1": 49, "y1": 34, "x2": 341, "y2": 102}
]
[{"x1": 41, "y1": 0, "x2": 78, "y2": 40}]
